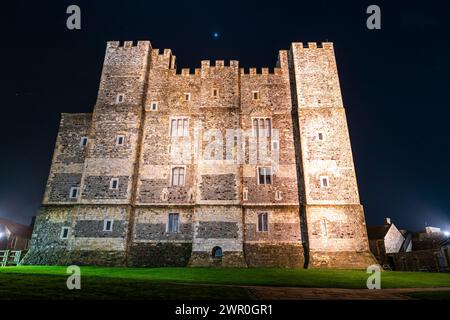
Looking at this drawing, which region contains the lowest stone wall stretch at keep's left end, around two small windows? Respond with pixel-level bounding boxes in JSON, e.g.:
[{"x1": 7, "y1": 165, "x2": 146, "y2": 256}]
[{"x1": 23, "y1": 205, "x2": 130, "y2": 265}]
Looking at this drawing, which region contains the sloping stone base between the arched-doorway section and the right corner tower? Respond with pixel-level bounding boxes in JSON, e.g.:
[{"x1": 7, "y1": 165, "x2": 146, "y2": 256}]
[{"x1": 244, "y1": 243, "x2": 305, "y2": 268}]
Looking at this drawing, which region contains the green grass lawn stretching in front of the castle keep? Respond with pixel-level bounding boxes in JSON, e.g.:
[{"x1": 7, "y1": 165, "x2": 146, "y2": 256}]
[{"x1": 0, "y1": 266, "x2": 450, "y2": 299}]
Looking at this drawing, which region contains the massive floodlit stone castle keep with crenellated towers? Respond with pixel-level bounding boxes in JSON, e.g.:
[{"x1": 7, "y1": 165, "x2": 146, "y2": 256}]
[{"x1": 24, "y1": 41, "x2": 375, "y2": 268}]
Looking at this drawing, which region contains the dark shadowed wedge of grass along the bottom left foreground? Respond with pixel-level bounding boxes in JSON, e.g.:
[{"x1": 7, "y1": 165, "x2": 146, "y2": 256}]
[{"x1": 0, "y1": 274, "x2": 252, "y2": 300}]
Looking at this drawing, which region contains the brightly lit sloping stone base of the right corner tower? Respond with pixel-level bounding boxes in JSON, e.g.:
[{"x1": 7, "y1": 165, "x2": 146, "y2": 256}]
[{"x1": 308, "y1": 251, "x2": 378, "y2": 269}]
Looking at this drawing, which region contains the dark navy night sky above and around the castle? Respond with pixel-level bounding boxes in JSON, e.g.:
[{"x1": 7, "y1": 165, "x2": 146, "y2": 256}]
[{"x1": 0, "y1": 0, "x2": 450, "y2": 229}]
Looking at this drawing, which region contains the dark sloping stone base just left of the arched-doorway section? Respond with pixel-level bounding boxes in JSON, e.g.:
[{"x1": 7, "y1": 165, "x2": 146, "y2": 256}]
[{"x1": 128, "y1": 243, "x2": 192, "y2": 267}]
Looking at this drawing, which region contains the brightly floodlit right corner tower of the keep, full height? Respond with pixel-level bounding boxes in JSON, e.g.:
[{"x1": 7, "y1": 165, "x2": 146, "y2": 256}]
[{"x1": 289, "y1": 42, "x2": 375, "y2": 268}]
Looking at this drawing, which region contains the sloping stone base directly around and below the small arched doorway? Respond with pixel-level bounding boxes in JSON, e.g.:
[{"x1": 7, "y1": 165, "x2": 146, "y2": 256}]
[{"x1": 189, "y1": 251, "x2": 247, "y2": 268}]
